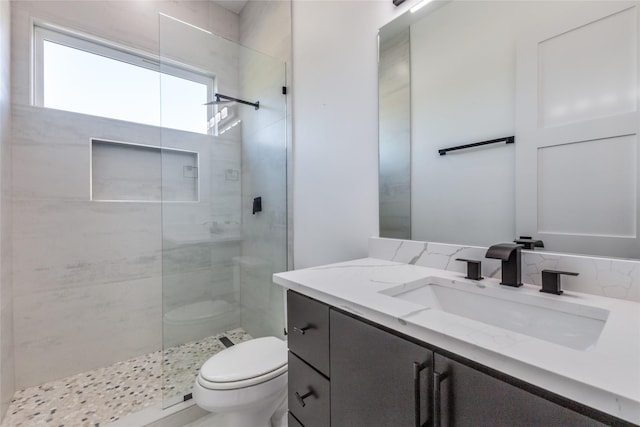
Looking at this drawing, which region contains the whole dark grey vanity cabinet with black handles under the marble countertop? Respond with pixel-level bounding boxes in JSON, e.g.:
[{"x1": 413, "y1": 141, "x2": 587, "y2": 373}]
[{"x1": 287, "y1": 291, "x2": 620, "y2": 427}]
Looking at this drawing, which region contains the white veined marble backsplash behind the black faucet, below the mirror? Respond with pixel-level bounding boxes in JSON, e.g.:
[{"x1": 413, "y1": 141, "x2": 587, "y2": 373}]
[{"x1": 369, "y1": 237, "x2": 640, "y2": 302}]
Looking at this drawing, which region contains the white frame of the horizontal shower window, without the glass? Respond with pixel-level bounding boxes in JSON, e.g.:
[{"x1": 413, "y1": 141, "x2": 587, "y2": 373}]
[{"x1": 31, "y1": 21, "x2": 215, "y2": 130}]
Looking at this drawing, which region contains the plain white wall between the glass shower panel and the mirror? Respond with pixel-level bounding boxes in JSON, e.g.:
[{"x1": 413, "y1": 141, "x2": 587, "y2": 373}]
[{"x1": 292, "y1": 0, "x2": 404, "y2": 268}]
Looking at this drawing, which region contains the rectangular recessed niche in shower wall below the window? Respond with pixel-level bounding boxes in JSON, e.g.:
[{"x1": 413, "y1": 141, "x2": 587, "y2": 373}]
[{"x1": 90, "y1": 138, "x2": 199, "y2": 202}]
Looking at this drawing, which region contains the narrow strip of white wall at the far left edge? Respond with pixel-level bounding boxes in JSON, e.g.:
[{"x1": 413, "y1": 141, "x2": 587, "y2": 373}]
[{"x1": 0, "y1": 0, "x2": 15, "y2": 420}]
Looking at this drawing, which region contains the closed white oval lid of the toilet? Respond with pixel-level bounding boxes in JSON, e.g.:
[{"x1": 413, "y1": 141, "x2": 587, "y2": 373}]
[{"x1": 200, "y1": 337, "x2": 287, "y2": 383}]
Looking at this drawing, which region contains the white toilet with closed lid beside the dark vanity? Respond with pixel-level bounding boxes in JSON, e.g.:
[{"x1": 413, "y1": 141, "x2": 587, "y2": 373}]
[{"x1": 193, "y1": 337, "x2": 287, "y2": 427}]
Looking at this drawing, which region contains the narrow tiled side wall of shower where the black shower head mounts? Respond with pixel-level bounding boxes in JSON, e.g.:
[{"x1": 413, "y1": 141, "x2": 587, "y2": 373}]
[{"x1": 236, "y1": 1, "x2": 291, "y2": 342}]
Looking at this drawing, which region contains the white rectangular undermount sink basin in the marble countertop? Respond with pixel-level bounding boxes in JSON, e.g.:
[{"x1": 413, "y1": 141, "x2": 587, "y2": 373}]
[{"x1": 380, "y1": 277, "x2": 609, "y2": 351}]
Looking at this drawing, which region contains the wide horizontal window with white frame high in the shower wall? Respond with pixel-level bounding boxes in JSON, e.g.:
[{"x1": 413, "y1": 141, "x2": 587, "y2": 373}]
[{"x1": 34, "y1": 24, "x2": 213, "y2": 133}]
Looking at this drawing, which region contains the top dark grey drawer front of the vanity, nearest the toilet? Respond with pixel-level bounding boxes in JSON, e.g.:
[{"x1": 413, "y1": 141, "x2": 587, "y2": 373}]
[{"x1": 287, "y1": 291, "x2": 329, "y2": 377}]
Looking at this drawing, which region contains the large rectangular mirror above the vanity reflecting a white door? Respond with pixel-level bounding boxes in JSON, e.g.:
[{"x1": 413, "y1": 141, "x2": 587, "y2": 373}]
[{"x1": 379, "y1": 1, "x2": 640, "y2": 259}]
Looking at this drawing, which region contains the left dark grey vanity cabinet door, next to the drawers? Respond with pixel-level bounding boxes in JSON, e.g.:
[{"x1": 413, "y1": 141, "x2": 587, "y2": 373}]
[{"x1": 330, "y1": 310, "x2": 433, "y2": 427}]
